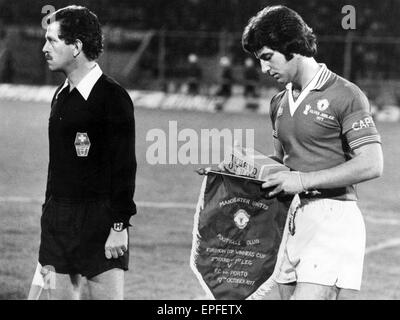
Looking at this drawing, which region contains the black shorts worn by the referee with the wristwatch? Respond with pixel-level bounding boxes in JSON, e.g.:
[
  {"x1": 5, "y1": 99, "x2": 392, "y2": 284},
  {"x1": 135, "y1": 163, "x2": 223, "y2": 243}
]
[{"x1": 39, "y1": 197, "x2": 129, "y2": 278}]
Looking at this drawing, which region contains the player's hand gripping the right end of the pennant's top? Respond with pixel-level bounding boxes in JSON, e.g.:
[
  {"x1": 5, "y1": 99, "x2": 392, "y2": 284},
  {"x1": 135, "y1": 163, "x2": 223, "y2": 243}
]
[{"x1": 262, "y1": 171, "x2": 305, "y2": 197}]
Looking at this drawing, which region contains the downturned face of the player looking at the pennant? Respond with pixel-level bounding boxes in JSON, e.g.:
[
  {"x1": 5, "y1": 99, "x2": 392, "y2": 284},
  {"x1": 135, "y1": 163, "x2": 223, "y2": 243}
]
[{"x1": 255, "y1": 46, "x2": 295, "y2": 84}]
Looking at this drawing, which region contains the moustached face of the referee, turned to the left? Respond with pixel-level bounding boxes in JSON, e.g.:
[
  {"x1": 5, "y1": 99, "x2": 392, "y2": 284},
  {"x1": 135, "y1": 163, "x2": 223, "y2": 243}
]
[{"x1": 43, "y1": 21, "x2": 74, "y2": 73}]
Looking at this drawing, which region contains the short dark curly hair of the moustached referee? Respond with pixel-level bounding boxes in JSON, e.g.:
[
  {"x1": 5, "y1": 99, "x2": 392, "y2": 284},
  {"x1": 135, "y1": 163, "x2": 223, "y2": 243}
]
[{"x1": 53, "y1": 5, "x2": 103, "y2": 60}]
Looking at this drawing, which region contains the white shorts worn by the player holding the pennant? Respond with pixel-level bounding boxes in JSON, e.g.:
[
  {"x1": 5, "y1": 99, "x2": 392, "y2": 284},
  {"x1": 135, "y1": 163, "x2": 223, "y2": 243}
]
[{"x1": 275, "y1": 199, "x2": 365, "y2": 290}]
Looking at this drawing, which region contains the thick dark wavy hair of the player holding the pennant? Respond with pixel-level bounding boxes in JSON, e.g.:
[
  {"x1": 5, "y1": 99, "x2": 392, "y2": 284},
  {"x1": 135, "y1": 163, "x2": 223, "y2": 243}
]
[{"x1": 242, "y1": 6, "x2": 317, "y2": 60}]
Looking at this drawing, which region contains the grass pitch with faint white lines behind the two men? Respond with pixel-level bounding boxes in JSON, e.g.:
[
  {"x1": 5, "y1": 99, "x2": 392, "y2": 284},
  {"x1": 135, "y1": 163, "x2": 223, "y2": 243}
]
[{"x1": 0, "y1": 100, "x2": 400, "y2": 300}]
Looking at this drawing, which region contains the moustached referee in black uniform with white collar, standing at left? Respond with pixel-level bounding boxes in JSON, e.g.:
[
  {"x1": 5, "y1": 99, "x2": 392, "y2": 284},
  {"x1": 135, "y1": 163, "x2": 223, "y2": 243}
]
[{"x1": 39, "y1": 6, "x2": 136, "y2": 299}]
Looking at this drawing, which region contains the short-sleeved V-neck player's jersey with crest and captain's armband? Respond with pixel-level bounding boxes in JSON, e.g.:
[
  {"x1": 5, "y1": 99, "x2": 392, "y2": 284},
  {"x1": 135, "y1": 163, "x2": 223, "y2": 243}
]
[{"x1": 270, "y1": 64, "x2": 381, "y2": 200}]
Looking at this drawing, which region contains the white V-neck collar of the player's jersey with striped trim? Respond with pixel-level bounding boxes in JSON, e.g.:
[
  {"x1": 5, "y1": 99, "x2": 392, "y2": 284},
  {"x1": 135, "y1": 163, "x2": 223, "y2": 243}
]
[{"x1": 286, "y1": 63, "x2": 331, "y2": 117}]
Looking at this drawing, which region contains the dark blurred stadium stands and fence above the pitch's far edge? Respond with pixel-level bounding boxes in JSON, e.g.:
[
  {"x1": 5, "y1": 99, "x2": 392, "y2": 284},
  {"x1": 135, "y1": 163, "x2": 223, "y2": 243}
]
[{"x1": 0, "y1": 0, "x2": 400, "y2": 119}]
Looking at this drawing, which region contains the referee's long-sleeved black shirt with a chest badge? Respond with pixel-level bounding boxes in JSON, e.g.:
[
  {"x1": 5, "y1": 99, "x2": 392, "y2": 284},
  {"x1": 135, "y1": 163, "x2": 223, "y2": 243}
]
[{"x1": 46, "y1": 74, "x2": 136, "y2": 224}]
